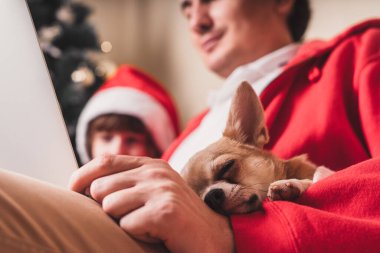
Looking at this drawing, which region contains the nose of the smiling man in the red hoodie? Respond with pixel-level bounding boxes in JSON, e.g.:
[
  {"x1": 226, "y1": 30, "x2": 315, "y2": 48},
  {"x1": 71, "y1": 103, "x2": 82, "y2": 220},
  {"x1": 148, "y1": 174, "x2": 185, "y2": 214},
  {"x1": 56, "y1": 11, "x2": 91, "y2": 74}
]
[{"x1": 189, "y1": 3, "x2": 213, "y2": 34}]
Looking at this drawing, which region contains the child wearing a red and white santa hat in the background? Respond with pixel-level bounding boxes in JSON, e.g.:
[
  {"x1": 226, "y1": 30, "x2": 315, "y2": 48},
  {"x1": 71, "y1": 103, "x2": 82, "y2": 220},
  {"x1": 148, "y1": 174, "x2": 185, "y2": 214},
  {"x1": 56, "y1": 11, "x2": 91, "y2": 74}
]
[{"x1": 76, "y1": 65, "x2": 179, "y2": 163}]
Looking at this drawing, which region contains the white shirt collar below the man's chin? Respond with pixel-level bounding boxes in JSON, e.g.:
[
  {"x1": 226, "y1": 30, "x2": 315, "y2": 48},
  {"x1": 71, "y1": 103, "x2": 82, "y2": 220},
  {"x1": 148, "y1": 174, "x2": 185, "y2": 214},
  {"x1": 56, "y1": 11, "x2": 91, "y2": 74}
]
[{"x1": 208, "y1": 43, "x2": 300, "y2": 107}]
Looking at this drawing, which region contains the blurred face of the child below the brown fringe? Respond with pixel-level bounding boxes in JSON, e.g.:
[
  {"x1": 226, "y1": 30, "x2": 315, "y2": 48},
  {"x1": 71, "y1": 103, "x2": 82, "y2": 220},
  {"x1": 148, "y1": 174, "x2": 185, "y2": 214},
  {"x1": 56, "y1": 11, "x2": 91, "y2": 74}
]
[{"x1": 91, "y1": 130, "x2": 151, "y2": 158}]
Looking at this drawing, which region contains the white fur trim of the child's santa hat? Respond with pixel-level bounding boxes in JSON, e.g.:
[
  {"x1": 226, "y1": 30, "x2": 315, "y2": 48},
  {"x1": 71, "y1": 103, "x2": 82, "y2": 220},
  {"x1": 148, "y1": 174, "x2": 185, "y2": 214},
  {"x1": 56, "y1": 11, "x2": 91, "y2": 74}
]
[{"x1": 76, "y1": 87, "x2": 175, "y2": 163}]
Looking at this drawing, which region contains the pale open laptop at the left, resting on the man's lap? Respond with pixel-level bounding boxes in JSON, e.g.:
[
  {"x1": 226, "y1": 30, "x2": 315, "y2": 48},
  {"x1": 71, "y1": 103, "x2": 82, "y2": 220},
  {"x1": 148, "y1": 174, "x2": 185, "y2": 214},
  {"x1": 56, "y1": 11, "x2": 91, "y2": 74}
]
[{"x1": 0, "y1": 0, "x2": 78, "y2": 187}]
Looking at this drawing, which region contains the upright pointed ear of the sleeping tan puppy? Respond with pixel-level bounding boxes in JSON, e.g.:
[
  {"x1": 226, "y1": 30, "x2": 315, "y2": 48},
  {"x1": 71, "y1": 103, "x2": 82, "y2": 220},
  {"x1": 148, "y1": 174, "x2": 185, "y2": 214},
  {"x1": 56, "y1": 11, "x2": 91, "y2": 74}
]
[{"x1": 223, "y1": 82, "x2": 269, "y2": 148}]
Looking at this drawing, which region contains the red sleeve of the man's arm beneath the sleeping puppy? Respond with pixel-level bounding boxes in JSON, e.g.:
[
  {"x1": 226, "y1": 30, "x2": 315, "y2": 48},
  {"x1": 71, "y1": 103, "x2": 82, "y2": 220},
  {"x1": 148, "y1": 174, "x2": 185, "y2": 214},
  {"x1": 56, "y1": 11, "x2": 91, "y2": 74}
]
[{"x1": 231, "y1": 158, "x2": 380, "y2": 253}]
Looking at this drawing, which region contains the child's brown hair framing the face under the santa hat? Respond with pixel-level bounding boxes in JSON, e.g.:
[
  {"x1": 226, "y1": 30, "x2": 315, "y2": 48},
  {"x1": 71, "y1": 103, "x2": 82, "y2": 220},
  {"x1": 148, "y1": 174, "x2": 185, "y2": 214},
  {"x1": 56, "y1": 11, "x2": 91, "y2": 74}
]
[{"x1": 86, "y1": 113, "x2": 161, "y2": 158}]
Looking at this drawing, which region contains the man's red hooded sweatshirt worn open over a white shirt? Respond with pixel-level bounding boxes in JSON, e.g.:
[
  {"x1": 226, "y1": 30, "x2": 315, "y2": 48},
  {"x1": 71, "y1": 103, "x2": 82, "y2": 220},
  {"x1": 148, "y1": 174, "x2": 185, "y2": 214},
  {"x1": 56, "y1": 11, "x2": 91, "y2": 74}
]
[{"x1": 164, "y1": 20, "x2": 380, "y2": 253}]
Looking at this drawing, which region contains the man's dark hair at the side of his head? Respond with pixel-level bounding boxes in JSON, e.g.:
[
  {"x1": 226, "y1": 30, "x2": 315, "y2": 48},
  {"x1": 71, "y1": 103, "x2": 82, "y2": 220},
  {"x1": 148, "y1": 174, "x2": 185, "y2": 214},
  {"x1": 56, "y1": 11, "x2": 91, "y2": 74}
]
[{"x1": 288, "y1": 0, "x2": 311, "y2": 42}]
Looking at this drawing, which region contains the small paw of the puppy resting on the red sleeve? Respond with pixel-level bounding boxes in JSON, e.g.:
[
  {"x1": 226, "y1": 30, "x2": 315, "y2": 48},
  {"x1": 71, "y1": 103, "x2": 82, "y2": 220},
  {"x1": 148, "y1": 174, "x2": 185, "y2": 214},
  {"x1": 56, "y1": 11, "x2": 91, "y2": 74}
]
[{"x1": 267, "y1": 179, "x2": 305, "y2": 201}]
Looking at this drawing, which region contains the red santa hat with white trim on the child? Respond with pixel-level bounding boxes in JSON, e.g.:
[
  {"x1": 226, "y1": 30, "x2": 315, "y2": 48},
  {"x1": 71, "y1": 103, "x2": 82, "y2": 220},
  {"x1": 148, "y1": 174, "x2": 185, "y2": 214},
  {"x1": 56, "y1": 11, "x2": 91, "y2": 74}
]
[{"x1": 76, "y1": 65, "x2": 179, "y2": 163}]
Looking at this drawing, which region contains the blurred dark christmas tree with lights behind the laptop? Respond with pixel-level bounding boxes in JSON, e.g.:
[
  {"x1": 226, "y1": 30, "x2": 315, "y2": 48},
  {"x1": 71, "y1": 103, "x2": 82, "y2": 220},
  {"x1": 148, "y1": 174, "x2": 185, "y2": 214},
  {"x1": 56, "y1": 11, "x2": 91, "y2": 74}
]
[{"x1": 27, "y1": 0, "x2": 112, "y2": 162}]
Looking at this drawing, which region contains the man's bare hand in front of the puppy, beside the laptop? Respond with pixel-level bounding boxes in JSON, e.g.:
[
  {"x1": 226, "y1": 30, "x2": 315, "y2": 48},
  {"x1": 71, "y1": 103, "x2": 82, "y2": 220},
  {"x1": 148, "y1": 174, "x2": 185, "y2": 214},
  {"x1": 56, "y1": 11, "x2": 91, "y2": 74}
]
[{"x1": 70, "y1": 155, "x2": 233, "y2": 253}]
